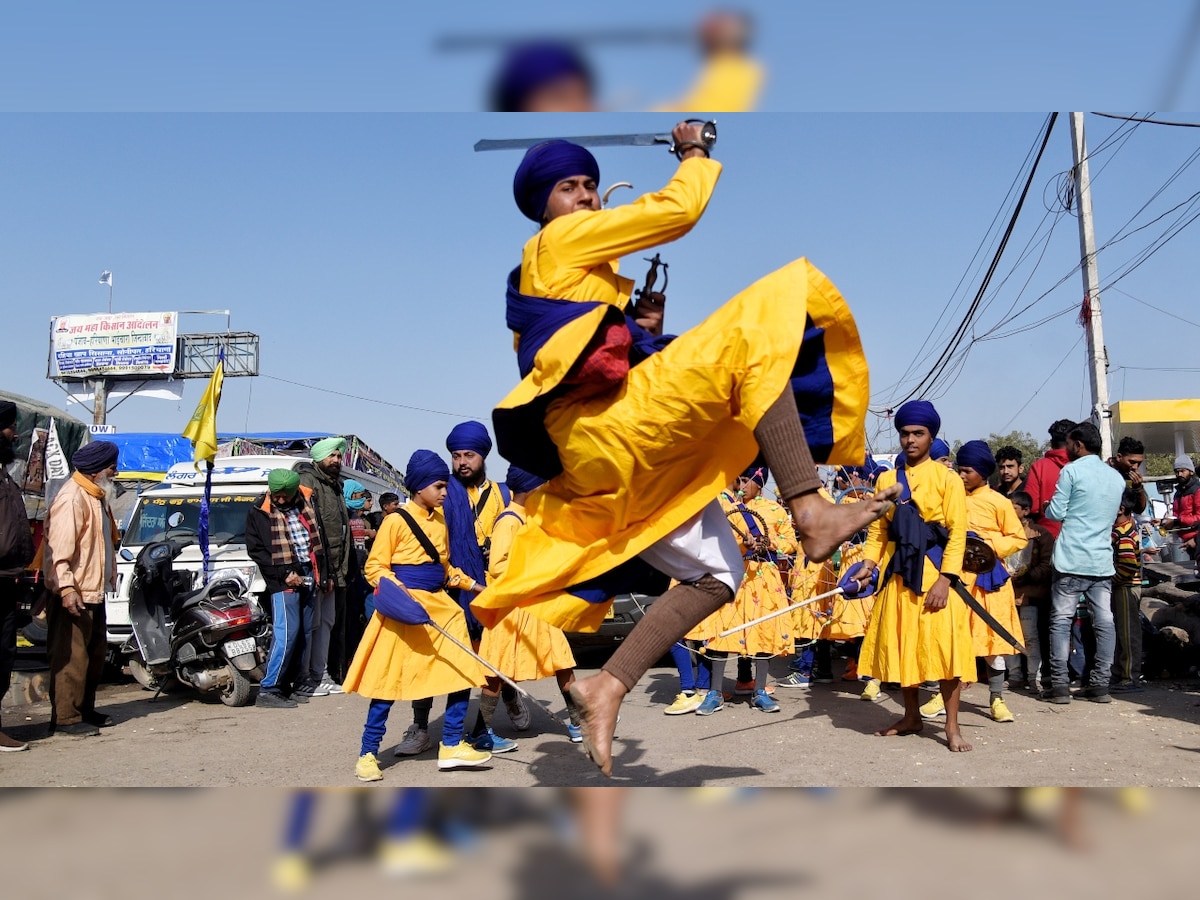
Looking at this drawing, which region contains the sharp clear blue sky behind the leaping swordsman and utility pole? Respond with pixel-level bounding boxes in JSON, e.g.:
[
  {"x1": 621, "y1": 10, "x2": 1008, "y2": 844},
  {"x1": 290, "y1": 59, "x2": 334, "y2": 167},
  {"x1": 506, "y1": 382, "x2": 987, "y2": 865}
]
[{"x1": 0, "y1": 113, "x2": 1200, "y2": 474}]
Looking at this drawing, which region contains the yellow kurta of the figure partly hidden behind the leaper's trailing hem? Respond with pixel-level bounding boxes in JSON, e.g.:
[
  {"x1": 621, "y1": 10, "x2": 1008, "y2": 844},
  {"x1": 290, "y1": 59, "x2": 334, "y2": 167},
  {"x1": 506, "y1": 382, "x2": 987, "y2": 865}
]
[{"x1": 479, "y1": 503, "x2": 575, "y2": 682}]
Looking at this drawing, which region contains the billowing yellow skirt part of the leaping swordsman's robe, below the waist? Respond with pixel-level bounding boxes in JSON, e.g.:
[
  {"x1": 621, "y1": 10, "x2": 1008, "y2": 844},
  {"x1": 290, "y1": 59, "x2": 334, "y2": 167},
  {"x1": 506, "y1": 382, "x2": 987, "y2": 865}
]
[{"x1": 472, "y1": 259, "x2": 870, "y2": 631}]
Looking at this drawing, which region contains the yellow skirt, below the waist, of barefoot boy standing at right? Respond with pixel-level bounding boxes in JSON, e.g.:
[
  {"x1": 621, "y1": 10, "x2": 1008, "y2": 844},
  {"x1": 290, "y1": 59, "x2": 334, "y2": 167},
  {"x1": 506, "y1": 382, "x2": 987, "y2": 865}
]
[{"x1": 858, "y1": 577, "x2": 976, "y2": 688}]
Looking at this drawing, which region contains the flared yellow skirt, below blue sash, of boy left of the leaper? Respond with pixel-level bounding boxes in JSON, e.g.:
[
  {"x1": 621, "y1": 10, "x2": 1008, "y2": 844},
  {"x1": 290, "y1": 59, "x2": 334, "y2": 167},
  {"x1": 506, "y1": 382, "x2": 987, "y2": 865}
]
[{"x1": 342, "y1": 588, "x2": 490, "y2": 700}]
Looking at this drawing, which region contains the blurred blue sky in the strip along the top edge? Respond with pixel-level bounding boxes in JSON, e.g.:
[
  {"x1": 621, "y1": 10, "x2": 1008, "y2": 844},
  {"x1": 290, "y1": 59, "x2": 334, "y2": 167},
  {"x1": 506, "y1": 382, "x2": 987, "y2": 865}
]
[{"x1": 0, "y1": 0, "x2": 1200, "y2": 112}]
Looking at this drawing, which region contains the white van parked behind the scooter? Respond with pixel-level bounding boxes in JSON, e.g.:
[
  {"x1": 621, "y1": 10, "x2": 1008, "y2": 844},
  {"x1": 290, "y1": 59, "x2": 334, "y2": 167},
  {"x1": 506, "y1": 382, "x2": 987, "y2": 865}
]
[{"x1": 104, "y1": 456, "x2": 403, "y2": 647}]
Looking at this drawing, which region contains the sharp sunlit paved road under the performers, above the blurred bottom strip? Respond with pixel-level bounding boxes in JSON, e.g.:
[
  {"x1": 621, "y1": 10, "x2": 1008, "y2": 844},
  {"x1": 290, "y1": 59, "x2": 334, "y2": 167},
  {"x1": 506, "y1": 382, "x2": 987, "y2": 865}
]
[{"x1": 0, "y1": 661, "x2": 1200, "y2": 787}]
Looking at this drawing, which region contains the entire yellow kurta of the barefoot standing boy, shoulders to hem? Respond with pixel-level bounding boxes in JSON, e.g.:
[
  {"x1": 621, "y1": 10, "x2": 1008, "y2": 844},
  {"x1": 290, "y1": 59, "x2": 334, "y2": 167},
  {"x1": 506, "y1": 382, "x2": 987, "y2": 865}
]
[{"x1": 858, "y1": 458, "x2": 976, "y2": 688}]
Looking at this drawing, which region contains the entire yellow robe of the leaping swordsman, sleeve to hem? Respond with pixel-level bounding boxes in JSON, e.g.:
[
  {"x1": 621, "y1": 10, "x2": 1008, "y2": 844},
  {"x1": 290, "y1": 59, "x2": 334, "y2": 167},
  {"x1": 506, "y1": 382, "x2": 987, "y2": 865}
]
[{"x1": 472, "y1": 160, "x2": 870, "y2": 631}]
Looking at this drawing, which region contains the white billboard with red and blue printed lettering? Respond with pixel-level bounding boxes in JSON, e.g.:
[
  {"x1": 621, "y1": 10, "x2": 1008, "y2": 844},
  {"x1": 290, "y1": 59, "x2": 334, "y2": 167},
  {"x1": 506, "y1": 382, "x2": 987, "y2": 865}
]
[{"x1": 49, "y1": 312, "x2": 179, "y2": 378}]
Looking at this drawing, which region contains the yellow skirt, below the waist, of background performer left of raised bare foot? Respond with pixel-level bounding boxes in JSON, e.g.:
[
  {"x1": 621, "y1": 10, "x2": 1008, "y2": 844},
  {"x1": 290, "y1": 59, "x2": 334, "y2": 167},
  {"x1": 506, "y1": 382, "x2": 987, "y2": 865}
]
[{"x1": 696, "y1": 559, "x2": 794, "y2": 656}]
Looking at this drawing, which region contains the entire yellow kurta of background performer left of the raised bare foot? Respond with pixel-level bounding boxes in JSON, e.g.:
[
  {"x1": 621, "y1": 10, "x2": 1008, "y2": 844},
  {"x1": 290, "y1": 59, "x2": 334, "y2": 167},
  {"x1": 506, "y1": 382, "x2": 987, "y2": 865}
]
[{"x1": 692, "y1": 493, "x2": 796, "y2": 656}]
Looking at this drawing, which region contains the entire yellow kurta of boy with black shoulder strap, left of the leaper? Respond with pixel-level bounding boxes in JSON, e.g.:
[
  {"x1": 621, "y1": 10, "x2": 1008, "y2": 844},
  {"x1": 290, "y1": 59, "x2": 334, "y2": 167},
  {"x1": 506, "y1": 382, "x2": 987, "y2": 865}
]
[{"x1": 342, "y1": 503, "x2": 488, "y2": 700}]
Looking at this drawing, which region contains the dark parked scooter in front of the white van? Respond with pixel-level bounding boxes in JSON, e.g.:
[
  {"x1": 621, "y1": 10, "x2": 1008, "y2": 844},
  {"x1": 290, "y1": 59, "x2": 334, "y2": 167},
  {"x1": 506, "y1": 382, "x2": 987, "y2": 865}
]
[{"x1": 121, "y1": 540, "x2": 270, "y2": 707}]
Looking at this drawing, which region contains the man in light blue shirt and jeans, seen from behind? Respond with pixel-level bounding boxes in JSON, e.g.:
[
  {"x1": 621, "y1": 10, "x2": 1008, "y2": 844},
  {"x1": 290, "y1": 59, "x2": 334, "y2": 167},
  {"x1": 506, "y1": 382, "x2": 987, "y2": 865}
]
[{"x1": 1043, "y1": 422, "x2": 1124, "y2": 703}]
